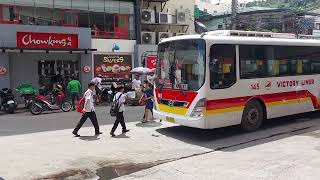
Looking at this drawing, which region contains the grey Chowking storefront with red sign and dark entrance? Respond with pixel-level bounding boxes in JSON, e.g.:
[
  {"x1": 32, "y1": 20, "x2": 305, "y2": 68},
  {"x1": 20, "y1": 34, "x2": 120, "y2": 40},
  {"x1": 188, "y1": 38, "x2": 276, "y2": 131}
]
[{"x1": 0, "y1": 25, "x2": 94, "y2": 96}]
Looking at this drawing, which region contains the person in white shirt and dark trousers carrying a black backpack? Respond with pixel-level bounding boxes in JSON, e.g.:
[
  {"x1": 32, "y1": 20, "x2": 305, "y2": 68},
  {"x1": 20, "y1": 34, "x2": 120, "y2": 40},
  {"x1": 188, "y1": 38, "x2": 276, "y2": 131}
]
[{"x1": 110, "y1": 86, "x2": 129, "y2": 137}]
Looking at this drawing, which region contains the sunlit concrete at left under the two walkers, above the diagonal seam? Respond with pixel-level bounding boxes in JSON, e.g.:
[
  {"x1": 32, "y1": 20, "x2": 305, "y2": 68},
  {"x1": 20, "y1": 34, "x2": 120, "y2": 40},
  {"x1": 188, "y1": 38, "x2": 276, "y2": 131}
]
[{"x1": 0, "y1": 122, "x2": 209, "y2": 180}]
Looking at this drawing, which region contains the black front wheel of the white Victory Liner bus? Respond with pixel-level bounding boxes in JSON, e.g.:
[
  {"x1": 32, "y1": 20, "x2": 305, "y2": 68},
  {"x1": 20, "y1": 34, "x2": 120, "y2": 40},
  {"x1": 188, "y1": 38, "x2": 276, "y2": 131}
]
[{"x1": 241, "y1": 100, "x2": 264, "y2": 131}]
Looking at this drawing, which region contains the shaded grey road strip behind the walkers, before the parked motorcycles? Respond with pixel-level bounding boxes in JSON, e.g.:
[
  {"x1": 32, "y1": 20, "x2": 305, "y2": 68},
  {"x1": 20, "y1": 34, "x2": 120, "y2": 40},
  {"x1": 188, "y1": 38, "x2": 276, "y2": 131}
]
[{"x1": 0, "y1": 106, "x2": 144, "y2": 136}]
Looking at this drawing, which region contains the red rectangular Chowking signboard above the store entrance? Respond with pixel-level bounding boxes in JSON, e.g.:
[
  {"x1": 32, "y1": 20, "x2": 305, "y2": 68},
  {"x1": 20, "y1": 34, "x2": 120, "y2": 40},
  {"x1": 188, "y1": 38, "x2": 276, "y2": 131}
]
[{"x1": 17, "y1": 32, "x2": 79, "y2": 49}]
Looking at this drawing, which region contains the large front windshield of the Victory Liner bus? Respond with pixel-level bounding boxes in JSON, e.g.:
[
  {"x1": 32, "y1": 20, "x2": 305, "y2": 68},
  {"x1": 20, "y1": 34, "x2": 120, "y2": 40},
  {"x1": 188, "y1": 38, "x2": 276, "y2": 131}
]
[{"x1": 156, "y1": 39, "x2": 206, "y2": 91}]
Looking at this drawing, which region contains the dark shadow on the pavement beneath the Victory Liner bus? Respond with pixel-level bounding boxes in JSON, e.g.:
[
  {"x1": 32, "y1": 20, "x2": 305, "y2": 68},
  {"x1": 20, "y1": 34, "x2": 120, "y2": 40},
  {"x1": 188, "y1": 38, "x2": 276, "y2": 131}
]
[{"x1": 157, "y1": 112, "x2": 320, "y2": 151}]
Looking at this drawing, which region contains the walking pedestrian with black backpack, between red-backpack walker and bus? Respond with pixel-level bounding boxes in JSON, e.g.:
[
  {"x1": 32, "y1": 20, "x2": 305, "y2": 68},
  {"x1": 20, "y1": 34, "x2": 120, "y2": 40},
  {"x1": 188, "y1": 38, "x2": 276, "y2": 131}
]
[{"x1": 110, "y1": 86, "x2": 129, "y2": 137}]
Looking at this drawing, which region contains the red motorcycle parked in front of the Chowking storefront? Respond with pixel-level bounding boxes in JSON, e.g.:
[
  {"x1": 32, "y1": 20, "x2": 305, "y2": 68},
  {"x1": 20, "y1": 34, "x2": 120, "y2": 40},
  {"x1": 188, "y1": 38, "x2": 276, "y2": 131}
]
[{"x1": 30, "y1": 85, "x2": 72, "y2": 115}]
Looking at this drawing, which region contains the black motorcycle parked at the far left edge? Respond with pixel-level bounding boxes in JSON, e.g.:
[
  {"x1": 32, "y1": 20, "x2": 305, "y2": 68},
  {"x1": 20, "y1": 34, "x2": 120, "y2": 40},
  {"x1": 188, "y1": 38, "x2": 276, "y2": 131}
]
[{"x1": 0, "y1": 88, "x2": 17, "y2": 114}]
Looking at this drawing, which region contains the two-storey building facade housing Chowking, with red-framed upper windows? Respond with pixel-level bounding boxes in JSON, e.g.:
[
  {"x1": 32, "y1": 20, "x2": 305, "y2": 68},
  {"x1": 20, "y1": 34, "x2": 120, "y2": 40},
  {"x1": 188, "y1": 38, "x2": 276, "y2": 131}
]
[{"x1": 0, "y1": 0, "x2": 136, "y2": 93}]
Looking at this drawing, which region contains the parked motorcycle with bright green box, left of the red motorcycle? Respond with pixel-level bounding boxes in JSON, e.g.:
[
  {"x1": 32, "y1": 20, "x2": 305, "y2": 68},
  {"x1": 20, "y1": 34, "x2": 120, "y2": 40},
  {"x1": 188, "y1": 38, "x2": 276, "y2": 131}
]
[{"x1": 16, "y1": 83, "x2": 36, "y2": 109}]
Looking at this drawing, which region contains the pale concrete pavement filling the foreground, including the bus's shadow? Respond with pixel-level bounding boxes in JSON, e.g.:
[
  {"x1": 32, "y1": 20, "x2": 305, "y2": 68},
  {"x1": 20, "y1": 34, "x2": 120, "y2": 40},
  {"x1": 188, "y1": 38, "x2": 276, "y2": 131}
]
[{"x1": 0, "y1": 110, "x2": 320, "y2": 180}]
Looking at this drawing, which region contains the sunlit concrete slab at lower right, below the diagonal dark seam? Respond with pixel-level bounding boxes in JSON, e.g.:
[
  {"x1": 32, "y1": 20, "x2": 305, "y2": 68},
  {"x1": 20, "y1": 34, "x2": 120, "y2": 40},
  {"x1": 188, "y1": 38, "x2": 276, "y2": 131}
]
[{"x1": 117, "y1": 126, "x2": 320, "y2": 180}]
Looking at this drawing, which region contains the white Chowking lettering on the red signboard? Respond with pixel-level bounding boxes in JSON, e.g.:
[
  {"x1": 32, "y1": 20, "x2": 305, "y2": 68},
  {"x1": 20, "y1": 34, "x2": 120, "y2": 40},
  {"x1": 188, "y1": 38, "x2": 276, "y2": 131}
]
[{"x1": 22, "y1": 34, "x2": 71, "y2": 46}]
